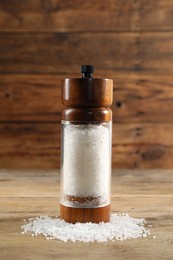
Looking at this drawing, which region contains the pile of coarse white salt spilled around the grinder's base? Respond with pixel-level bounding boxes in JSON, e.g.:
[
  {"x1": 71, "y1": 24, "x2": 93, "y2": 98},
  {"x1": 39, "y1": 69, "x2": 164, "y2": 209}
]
[{"x1": 21, "y1": 214, "x2": 150, "y2": 242}]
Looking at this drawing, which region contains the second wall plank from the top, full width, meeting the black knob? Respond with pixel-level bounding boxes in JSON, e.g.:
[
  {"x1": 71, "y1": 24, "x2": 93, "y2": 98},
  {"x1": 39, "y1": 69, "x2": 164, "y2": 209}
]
[{"x1": 0, "y1": 32, "x2": 173, "y2": 73}]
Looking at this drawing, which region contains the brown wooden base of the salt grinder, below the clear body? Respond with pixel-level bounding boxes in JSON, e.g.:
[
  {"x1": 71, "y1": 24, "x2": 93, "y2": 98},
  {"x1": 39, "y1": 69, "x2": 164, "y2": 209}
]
[{"x1": 60, "y1": 204, "x2": 111, "y2": 224}]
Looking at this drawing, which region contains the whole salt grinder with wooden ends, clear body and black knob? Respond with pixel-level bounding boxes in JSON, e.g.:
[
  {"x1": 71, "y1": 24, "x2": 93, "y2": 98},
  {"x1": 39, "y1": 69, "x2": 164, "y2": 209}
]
[{"x1": 60, "y1": 65, "x2": 113, "y2": 223}]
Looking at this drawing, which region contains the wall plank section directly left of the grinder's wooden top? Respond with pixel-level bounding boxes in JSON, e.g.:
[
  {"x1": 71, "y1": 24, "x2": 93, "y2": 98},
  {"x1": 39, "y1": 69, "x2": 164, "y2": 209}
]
[{"x1": 0, "y1": 74, "x2": 64, "y2": 122}]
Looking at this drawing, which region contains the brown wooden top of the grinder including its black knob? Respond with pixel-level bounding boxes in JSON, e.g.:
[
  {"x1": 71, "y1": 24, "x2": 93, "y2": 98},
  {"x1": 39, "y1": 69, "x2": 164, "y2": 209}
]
[{"x1": 61, "y1": 65, "x2": 113, "y2": 121}]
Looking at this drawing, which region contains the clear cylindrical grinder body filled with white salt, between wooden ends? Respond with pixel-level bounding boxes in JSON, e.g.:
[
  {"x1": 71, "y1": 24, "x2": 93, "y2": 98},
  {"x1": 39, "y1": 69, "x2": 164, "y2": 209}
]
[{"x1": 60, "y1": 121, "x2": 112, "y2": 208}]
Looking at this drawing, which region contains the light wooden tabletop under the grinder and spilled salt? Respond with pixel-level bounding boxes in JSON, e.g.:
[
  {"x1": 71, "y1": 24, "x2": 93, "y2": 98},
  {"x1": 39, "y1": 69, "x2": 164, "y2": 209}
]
[{"x1": 0, "y1": 170, "x2": 173, "y2": 260}]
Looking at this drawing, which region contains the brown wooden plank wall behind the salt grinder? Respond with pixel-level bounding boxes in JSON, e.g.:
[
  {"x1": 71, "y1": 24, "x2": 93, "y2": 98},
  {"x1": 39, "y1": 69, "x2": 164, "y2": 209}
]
[{"x1": 0, "y1": 0, "x2": 173, "y2": 168}]
